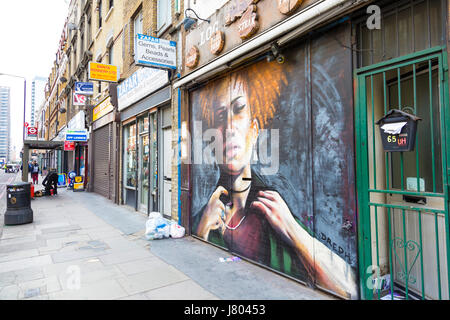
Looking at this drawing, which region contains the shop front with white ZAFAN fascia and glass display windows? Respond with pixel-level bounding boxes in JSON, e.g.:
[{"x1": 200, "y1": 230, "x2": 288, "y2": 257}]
[{"x1": 117, "y1": 68, "x2": 172, "y2": 217}]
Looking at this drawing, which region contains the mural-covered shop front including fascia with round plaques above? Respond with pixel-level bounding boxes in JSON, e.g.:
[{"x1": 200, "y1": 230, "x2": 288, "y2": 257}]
[{"x1": 174, "y1": 1, "x2": 359, "y2": 299}]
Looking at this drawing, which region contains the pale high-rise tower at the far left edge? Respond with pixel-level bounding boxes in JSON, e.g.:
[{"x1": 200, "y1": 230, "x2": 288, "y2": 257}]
[{"x1": 0, "y1": 87, "x2": 11, "y2": 161}]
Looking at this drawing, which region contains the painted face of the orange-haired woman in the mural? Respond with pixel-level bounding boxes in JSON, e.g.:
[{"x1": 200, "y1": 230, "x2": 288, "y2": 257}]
[{"x1": 214, "y1": 77, "x2": 258, "y2": 175}]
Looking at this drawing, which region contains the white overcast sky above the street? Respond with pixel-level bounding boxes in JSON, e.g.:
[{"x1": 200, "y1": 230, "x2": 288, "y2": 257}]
[{"x1": 0, "y1": 0, "x2": 69, "y2": 160}]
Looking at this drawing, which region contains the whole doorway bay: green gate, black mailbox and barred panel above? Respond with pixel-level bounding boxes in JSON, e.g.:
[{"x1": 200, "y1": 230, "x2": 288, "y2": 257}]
[{"x1": 353, "y1": 0, "x2": 450, "y2": 300}]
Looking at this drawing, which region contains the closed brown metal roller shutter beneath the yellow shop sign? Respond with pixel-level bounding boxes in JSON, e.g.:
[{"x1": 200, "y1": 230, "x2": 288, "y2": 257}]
[{"x1": 93, "y1": 124, "x2": 111, "y2": 198}]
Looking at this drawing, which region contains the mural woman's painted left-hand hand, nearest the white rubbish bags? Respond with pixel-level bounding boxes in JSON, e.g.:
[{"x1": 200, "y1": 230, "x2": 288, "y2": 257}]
[{"x1": 197, "y1": 186, "x2": 228, "y2": 240}]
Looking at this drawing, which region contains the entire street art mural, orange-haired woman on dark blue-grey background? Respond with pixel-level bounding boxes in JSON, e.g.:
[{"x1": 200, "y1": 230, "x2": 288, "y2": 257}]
[{"x1": 190, "y1": 26, "x2": 358, "y2": 299}]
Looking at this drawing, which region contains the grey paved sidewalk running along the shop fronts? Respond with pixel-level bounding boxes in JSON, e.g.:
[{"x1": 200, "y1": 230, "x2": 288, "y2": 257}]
[{"x1": 0, "y1": 180, "x2": 333, "y2": 300}]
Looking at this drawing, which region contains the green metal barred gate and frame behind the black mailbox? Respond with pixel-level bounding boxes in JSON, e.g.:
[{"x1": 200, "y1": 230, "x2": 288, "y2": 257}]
[{"x1": 355, "y1": 47, "x2": 450, "y2": 299}]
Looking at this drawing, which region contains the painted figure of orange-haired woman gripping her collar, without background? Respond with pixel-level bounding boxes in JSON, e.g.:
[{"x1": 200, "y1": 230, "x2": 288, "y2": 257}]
[{"x1": 194, "y1": 62, "x2": 357, "y2": 297}]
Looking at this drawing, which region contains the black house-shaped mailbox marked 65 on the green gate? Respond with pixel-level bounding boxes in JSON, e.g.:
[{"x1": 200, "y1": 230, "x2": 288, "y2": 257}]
[{"x1": 377, "y1": 109, "x2": 422, "y2": 152}]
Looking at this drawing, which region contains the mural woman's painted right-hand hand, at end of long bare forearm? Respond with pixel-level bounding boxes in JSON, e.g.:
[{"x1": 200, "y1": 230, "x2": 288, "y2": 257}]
[{"x1": 251, "y1": 191, "x2": 298, "y2": 245}]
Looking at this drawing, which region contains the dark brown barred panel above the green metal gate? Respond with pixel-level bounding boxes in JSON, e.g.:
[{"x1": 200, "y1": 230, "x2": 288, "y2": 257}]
[{"x1": 355, "y1": 0, "x2": 447, "y2": 67}]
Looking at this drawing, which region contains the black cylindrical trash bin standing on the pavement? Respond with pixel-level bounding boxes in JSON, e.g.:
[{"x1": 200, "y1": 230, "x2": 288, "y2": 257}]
[{"x1": 4, "y1": 182, "x2": 33, "y2": 225}]
